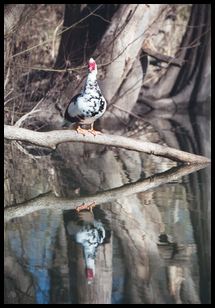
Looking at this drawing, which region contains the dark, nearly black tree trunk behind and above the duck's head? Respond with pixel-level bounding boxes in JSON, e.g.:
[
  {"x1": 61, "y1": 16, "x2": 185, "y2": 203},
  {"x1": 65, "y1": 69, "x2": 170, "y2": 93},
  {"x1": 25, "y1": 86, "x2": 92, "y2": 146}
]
[{"x1": 55, "y1": 4, "x2": 118, "y2": 68}]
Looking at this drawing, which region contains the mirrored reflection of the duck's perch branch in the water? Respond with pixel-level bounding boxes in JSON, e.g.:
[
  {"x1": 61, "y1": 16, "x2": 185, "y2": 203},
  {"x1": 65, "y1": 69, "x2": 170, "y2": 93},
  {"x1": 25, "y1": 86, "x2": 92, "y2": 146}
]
[{"x1": 4, "y1": 164, "x2": 207, "y2": 222}]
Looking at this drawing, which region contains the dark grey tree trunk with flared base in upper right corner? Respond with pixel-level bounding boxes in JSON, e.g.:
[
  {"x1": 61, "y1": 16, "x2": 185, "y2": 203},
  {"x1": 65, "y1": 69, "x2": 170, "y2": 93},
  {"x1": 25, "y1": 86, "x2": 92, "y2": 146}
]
[{"x1": 139, "y1": 4, "x2": 211, "y2": 110}]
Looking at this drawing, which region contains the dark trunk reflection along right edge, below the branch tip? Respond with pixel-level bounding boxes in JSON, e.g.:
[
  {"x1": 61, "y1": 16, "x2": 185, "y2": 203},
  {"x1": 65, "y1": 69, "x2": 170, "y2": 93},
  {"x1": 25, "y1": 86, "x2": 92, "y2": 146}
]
[{"x1": 187, "y1": 168, "x2": 211, "y2": 304}]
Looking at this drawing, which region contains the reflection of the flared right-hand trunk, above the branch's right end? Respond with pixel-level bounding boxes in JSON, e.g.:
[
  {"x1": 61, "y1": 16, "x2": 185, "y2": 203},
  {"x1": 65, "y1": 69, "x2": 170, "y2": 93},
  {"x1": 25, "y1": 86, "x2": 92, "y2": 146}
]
[{"x1": 135, "y1": 108, "x2": 211, "y2": 158}]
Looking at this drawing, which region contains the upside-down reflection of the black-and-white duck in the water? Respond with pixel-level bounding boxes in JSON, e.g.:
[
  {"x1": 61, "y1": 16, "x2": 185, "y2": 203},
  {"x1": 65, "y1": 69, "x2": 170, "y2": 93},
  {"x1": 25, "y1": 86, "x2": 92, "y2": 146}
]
[{"x1": 66, "y1": 204, "x2": 111, "y2": 284}]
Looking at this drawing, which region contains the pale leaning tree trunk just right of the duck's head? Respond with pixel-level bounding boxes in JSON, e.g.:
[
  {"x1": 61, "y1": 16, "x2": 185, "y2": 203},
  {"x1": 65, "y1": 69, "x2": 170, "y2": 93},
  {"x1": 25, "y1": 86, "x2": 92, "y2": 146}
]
[{"x1": 95, "y1": 4, "x2": 166, "y2": 103}]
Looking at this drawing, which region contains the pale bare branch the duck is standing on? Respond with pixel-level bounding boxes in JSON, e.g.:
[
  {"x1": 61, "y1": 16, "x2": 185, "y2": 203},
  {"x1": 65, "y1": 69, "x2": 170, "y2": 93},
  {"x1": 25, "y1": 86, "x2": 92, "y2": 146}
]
[{"x1": 4, "y1": 125, "x2": 210, "y2": 164}]
